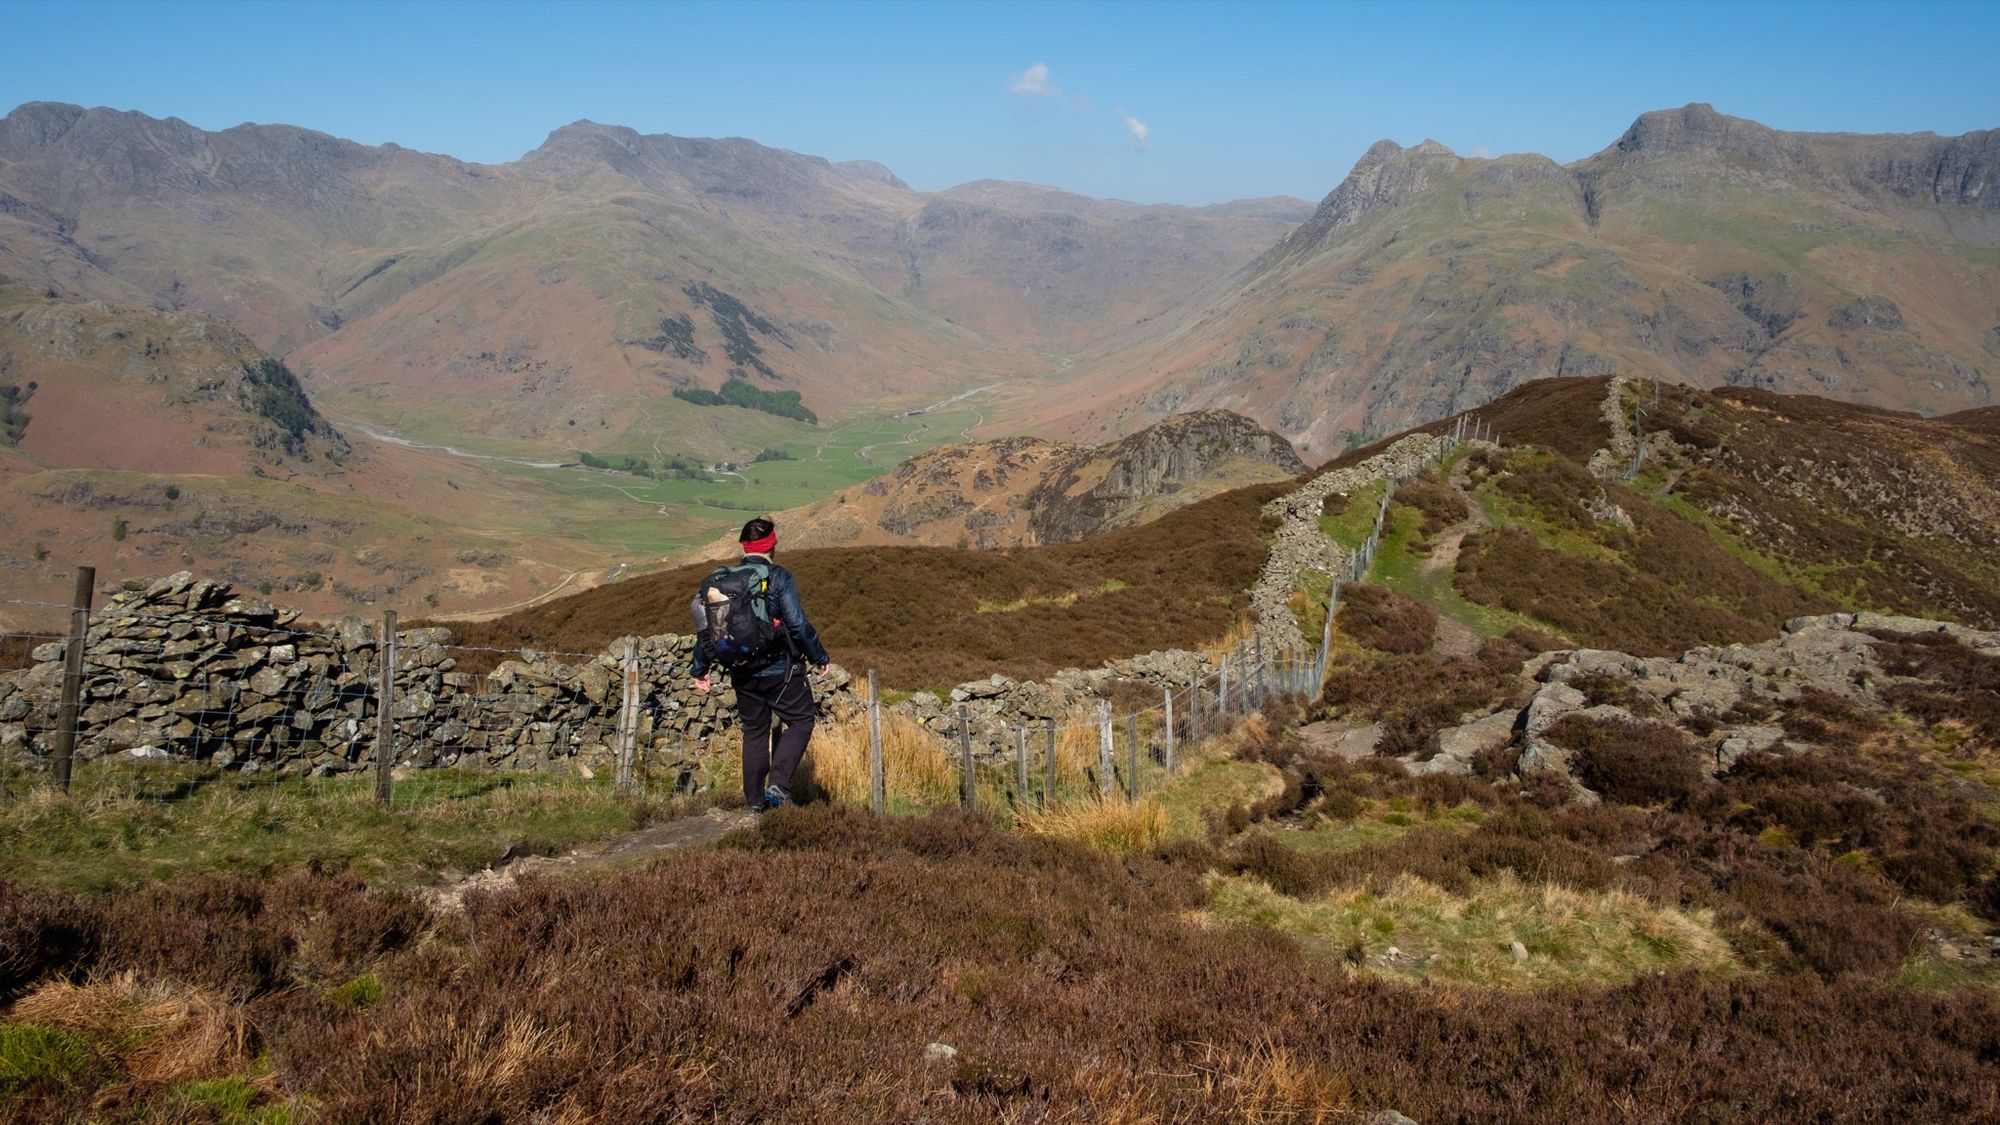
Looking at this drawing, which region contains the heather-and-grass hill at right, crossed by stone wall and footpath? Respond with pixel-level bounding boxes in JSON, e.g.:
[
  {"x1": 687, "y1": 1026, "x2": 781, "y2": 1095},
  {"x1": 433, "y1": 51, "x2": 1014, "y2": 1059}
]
[{"x1": 1294, "y1": 378, "x2": 2000, "y2": 755}]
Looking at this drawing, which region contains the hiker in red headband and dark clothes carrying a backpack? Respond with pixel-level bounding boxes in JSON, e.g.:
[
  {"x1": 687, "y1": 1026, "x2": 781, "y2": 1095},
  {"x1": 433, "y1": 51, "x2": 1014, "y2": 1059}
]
[{"x1": 690, "y1": 516, "x2": 828, "y2": 813}]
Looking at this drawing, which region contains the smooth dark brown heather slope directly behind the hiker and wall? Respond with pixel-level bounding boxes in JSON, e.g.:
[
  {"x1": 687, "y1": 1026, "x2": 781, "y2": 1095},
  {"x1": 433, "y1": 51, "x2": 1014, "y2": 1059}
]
[{"x1": 430, "y1": 476, "x2": 1282, "y2": 689}]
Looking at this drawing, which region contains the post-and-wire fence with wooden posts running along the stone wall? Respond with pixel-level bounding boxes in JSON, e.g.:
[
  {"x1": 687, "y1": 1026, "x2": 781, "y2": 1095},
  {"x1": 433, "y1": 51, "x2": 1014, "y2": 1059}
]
[{"x1": 0, "y1": 577, "x2": 1312, "y2": 809}]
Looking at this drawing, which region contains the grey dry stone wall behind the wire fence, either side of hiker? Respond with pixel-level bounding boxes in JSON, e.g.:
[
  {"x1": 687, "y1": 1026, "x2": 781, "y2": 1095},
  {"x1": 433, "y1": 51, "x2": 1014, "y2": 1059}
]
[{"x1": 0, "y1": 573, "x2": 1240, "y2": 777}]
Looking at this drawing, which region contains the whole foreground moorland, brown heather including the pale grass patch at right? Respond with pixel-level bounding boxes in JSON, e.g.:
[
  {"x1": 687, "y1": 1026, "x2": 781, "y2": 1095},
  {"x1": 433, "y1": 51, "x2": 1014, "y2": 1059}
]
[{"x1": 0, "y1": 672, "x2": 2000, "y2": 1121}]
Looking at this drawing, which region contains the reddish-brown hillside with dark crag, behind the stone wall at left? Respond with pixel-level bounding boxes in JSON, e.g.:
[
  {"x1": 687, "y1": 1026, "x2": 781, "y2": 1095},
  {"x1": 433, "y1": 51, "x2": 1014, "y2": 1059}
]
[{"x1": 0, "y1": 284, "x2": 608, "y2": 627}]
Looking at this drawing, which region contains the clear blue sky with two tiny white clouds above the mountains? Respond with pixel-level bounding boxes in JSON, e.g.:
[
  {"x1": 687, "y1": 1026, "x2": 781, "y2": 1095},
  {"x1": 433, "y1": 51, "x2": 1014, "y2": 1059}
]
[{"x1": 11, "y1": 0, "x2": 2000, "y2": 204}]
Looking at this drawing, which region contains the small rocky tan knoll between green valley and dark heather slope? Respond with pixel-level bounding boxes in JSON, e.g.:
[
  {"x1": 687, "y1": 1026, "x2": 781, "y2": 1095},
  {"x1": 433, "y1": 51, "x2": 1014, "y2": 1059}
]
[{"x1": 756, "y1": 410, "x2": 1306, "y2": 550}]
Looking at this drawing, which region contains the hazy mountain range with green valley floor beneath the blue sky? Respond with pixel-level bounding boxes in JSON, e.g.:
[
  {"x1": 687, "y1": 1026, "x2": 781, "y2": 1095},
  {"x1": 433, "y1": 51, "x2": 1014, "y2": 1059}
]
[{"x1": 0, "y1": 104, "x2": 2000, "y2": 613}]
